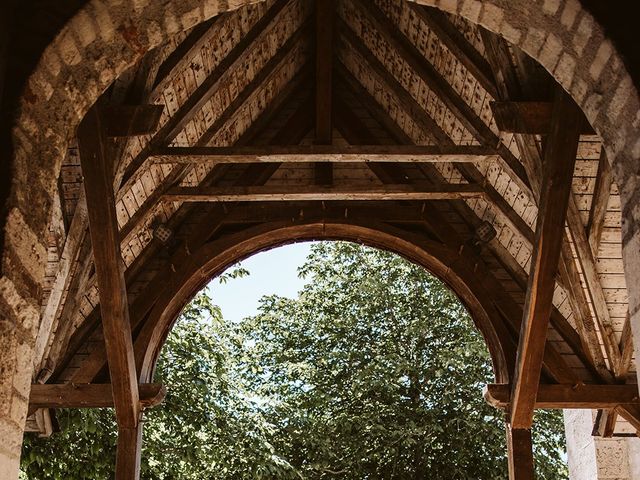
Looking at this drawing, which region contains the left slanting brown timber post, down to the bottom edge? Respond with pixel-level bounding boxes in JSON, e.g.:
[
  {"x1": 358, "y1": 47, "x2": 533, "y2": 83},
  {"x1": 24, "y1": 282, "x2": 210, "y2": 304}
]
[{"x1": 78, "y1": 107, "x2": 142, "y2": 480}]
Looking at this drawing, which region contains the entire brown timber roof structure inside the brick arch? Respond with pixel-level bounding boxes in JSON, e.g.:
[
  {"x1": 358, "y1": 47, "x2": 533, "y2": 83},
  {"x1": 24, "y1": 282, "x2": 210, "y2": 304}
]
[{"x1": 30, "y1": 0, "x2": 640, "y2": 479}]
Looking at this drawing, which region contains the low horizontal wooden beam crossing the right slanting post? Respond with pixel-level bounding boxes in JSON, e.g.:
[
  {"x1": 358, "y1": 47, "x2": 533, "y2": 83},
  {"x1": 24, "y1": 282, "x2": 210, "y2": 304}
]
[{"x1": 484, "y1": 383, "x2": 640, "y2": 410}]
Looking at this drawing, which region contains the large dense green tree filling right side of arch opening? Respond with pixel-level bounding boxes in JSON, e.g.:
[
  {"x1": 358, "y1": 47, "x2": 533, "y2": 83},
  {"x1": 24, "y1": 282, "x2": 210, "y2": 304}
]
[{"x1": 241, "y1": 242, "x2": 567, "y2": 480}]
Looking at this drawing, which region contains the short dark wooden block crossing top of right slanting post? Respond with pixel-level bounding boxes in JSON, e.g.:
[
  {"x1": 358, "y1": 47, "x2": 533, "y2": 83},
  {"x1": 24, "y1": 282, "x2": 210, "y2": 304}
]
[{"x1": 490, "y1": 101, "x2": 595, "y2": 135}]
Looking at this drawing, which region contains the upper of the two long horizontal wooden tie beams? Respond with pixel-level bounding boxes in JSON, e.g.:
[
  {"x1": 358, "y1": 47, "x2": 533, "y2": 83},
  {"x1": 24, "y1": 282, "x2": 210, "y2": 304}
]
[{"x1": 149, "y1": 145, "x2": 497, "y2": 164}]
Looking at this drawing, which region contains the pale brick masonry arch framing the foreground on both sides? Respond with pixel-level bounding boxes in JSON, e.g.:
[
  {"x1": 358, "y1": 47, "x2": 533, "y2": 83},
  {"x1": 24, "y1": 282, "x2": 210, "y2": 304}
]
[{"x1": 0, "y1": 0, "x2": 640, "y2": 478}]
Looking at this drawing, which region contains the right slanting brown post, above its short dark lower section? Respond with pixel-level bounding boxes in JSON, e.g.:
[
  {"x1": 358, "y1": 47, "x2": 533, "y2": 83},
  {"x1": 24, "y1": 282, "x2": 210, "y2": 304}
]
[{"x1": 510, "y1": 89, "x2": 580, "y2": 429}]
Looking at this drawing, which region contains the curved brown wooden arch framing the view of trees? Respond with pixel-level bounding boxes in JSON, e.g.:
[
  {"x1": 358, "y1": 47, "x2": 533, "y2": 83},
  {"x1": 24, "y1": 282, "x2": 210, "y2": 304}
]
[{"x1": 134, "y1": 219, "x2": 515, "y2": 383}]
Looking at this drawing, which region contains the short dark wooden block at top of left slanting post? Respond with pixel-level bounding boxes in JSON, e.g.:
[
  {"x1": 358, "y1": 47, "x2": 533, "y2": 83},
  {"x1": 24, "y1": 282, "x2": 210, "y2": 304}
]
[{"x1": 100, "y1": 105, "x2": 164, "y2": 137}]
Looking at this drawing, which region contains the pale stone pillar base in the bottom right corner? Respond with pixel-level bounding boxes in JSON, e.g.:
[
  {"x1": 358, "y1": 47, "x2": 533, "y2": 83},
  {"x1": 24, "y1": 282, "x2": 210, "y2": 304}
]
[{"x1": 564, "y1": 410, "x2": 640, "y2": 480}]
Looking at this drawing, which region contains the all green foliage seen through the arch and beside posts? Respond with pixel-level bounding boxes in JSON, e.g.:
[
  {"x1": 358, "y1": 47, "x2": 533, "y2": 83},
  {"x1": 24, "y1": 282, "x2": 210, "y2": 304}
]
[{"x1": 22, "y1": 242, "x2": 567, "y2": 480}]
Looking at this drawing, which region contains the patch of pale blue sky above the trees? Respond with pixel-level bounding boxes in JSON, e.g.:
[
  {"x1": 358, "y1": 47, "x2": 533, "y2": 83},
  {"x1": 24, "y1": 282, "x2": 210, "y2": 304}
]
[{"x1": 208, "y1": 242, "x2": 311, "y2": 321}]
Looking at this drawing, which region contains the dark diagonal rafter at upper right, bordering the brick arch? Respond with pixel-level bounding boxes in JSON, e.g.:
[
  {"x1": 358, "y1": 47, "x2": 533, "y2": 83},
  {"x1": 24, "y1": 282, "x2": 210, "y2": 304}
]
[{"x1": 408, "y1": 3, "x2": 498, "y2": 98}]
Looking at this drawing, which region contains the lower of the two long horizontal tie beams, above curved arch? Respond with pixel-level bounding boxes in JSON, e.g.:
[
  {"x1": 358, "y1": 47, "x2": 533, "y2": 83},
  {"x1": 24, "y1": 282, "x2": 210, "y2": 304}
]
[{"x1": 164, "y1": 183, "x2": 484, "y2": 202}]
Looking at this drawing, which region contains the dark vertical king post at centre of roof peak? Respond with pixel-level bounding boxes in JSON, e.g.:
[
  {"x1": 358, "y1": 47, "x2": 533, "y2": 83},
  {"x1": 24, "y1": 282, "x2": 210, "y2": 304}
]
[{"x1": 315, "y1": 0, "x2": 335, "y2": 185}]
